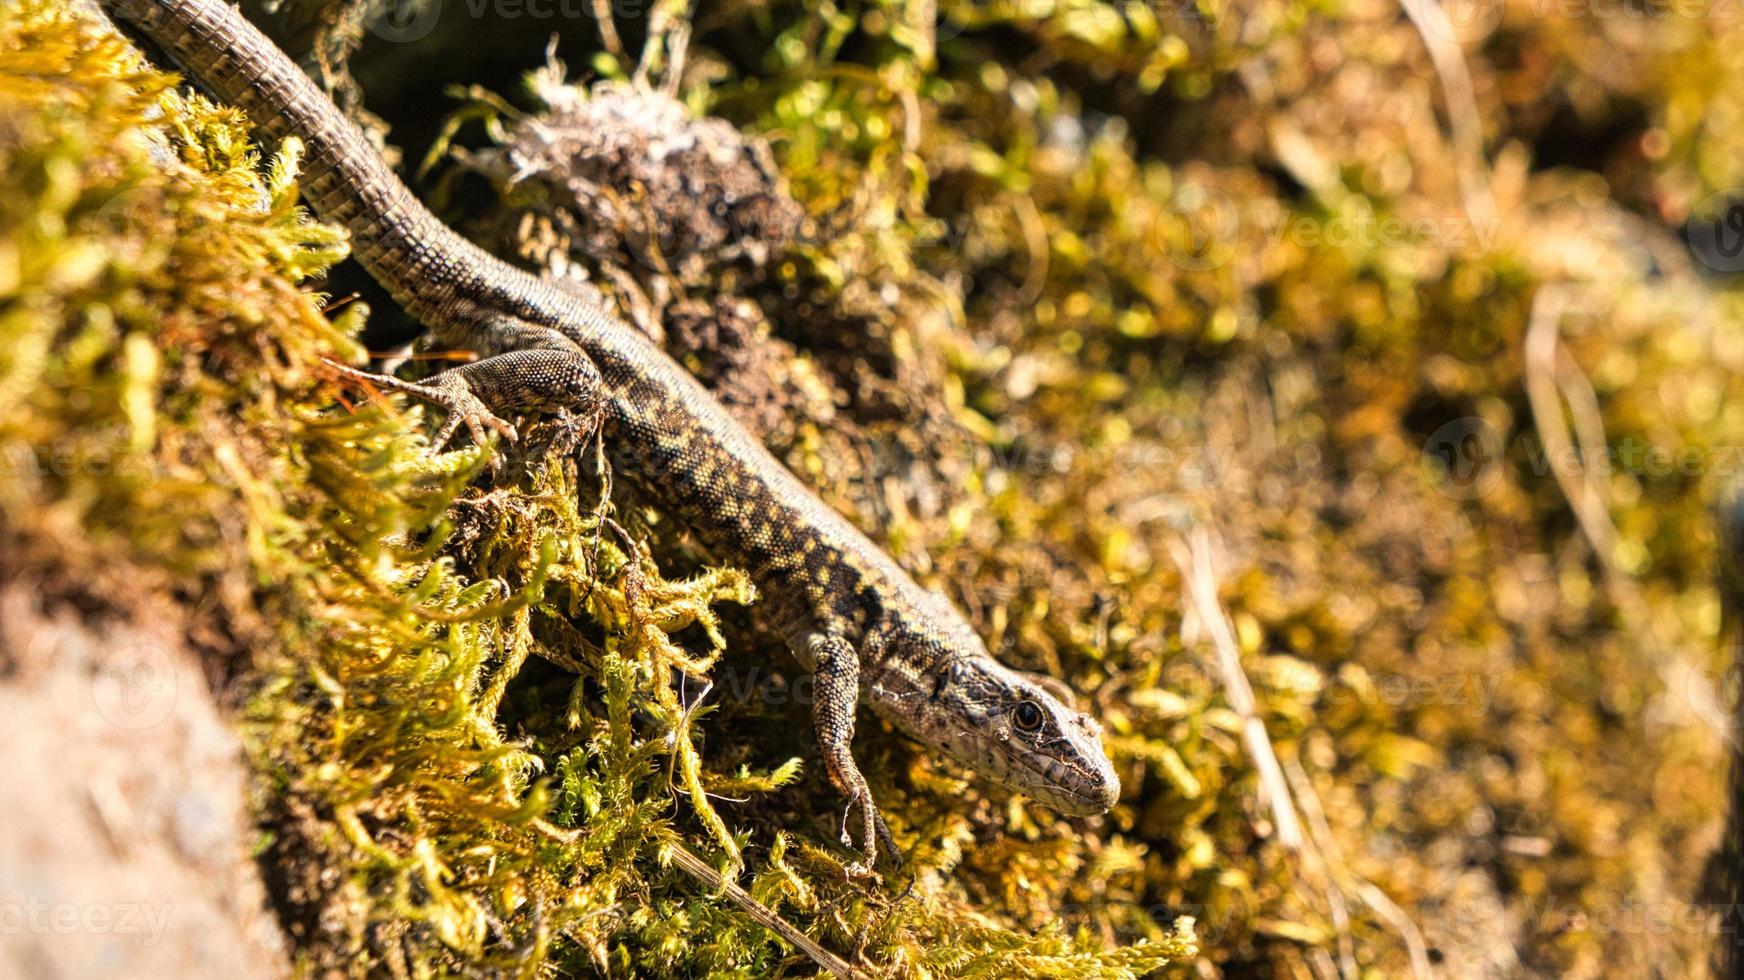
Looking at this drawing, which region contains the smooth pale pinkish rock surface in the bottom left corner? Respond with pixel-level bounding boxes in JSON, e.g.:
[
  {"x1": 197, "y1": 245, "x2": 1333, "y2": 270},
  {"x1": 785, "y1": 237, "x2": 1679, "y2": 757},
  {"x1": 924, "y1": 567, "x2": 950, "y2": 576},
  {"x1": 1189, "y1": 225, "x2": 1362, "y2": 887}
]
[{"x1": 0, "y1": 581, "x2": 288, "y2": 978}]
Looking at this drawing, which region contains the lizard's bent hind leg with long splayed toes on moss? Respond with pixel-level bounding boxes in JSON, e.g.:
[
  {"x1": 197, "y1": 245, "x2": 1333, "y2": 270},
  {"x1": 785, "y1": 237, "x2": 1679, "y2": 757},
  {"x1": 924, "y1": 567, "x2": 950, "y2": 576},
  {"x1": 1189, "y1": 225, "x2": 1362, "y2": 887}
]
[{"x1": 330, "y1": 317, "x2": 603, "y2": 452}]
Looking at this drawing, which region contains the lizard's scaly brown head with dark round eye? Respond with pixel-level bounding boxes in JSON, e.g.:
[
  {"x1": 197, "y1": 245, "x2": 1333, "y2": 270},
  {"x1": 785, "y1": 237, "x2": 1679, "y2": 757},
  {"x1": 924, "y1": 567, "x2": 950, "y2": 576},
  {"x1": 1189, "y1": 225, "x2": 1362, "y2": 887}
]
[{"x1": 872, "y1": 654, "x2": 1120, "y2": 816}]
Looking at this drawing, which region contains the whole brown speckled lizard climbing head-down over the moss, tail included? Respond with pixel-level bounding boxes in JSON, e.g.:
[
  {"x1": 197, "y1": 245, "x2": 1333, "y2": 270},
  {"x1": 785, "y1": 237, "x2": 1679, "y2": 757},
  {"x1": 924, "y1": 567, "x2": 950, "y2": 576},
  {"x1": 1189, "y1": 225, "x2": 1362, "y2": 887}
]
[{"x1": 98, "y1": 0, "x2": 1120, "y2": 875}]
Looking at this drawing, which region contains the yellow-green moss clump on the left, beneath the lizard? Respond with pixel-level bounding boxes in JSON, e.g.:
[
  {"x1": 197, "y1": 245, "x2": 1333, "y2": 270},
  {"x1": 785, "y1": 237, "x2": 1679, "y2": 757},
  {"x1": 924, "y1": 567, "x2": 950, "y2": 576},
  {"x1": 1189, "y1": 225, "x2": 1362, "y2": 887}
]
[{"x1": 0, "y1": 3, "x2": 1193, "y2": 977}]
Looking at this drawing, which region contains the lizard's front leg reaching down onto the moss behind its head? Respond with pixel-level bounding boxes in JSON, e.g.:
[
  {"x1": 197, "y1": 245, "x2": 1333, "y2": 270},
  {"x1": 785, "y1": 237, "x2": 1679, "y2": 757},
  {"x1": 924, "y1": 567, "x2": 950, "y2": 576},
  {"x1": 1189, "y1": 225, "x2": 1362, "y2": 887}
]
[{"x1": 809, "y1": 635, "x2": 902, "y2": 877}]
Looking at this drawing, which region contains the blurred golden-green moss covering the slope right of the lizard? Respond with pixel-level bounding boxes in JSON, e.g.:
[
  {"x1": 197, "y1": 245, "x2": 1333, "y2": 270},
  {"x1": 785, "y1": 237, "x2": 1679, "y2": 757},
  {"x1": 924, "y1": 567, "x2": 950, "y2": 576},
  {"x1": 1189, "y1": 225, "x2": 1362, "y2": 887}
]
[{"x1": 456, "y1": 2, "x2": 1744, "y2": 977}]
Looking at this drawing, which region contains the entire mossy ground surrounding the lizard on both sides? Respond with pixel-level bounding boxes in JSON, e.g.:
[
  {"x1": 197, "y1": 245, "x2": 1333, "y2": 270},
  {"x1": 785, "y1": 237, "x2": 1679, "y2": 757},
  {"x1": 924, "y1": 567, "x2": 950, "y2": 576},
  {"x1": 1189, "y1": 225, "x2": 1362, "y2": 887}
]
[{"x1": 0, "y1": 0, "x2": 1744, "y2": 977}]
